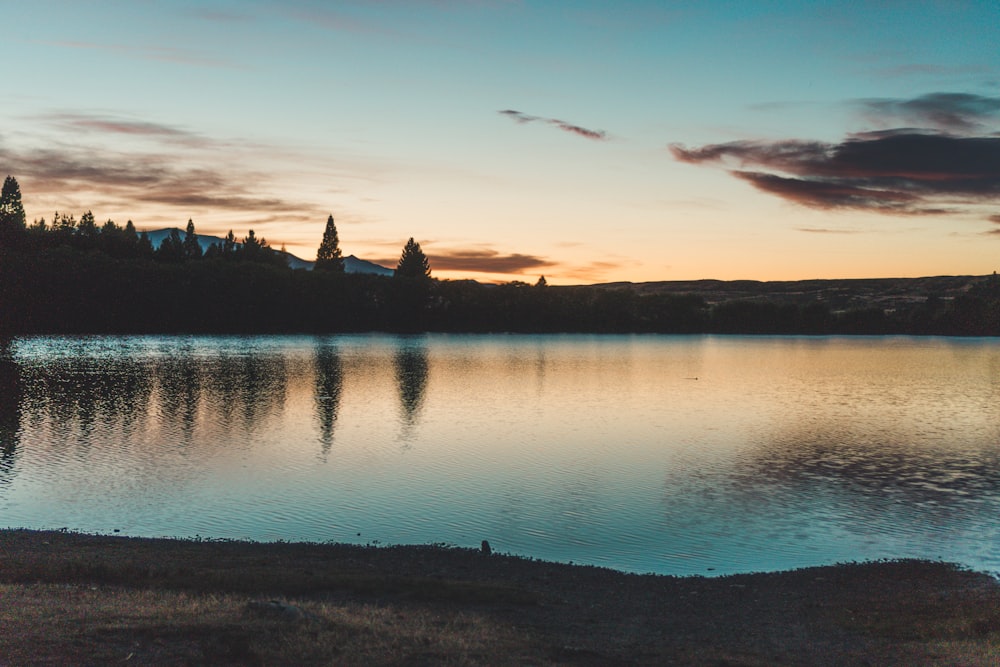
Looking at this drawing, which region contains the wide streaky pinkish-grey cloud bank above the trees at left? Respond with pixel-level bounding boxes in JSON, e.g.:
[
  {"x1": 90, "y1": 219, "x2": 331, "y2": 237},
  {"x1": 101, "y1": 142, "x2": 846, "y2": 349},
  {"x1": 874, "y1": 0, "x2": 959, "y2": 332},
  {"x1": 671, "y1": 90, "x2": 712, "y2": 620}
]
[{"x1": 0, "y1": 112, "x2": 354, "y2": 224}]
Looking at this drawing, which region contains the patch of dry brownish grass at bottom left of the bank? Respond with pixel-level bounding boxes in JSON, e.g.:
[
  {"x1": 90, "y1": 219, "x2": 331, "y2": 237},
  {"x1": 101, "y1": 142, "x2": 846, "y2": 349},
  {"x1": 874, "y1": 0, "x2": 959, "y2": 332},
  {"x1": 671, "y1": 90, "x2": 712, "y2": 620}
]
[{"x1": 0, "y1": 584, "x2": 527, "y2": 665}]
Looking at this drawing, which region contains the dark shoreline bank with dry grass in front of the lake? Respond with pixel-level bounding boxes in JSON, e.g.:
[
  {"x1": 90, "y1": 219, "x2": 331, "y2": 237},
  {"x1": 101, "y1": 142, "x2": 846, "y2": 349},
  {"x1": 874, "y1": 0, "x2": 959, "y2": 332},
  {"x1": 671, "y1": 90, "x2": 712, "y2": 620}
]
[{"x1": 0, "y1": 530, "x2": 1000, "y2": 665}]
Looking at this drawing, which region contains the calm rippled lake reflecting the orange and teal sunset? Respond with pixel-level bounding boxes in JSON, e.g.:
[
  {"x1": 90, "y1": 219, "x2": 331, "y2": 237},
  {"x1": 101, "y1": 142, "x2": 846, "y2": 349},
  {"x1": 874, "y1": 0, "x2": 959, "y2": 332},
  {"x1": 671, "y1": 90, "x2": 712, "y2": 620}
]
[{"x1": 0, "y1": 335, "x2": 1000, "y2": 574}]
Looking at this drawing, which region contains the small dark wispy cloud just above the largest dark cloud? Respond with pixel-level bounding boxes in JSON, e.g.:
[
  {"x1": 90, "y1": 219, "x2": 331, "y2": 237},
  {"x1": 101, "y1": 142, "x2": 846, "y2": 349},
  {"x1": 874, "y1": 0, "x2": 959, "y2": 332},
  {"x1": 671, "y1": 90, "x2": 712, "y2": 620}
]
[{"x1": 861, "y1": 93, "x2": 1000, "y2": 134}]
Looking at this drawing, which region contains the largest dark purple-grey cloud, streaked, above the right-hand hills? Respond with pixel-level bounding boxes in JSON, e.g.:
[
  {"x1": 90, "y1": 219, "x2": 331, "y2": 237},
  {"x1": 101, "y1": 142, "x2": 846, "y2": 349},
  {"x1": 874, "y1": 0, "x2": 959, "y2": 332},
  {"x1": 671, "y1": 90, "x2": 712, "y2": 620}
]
[{"x1": 670, "y1": 130, "x2": 1000, "y2": 214}]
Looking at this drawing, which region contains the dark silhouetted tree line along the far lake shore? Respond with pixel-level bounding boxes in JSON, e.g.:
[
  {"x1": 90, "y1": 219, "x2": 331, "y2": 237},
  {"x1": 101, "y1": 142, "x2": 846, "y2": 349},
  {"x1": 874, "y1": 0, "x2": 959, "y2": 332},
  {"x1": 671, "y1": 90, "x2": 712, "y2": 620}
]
[{"x1": 0, "y1": 176, "x2": 1000, "y2": 335}]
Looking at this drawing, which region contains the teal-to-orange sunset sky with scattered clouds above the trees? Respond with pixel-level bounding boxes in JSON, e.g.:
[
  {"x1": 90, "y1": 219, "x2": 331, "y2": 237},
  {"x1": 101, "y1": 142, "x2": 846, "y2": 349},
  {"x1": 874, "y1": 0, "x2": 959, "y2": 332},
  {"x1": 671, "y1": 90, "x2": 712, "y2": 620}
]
[{"x1": 0, "y1": 0, "x2": 1000, "y2": 284}]
